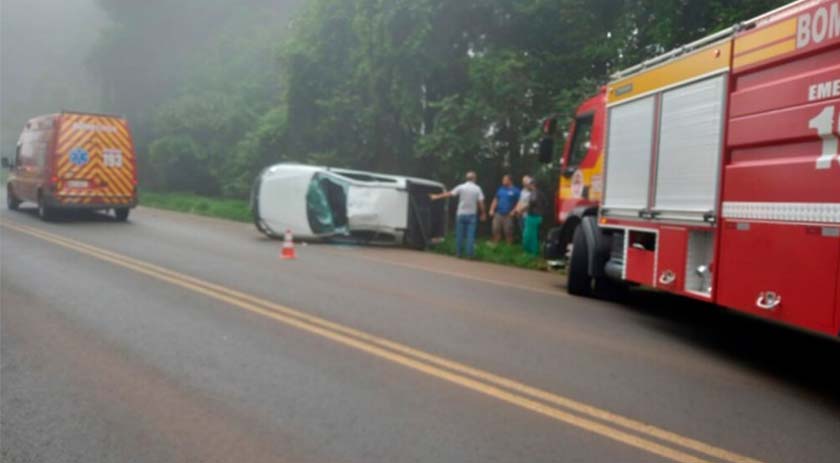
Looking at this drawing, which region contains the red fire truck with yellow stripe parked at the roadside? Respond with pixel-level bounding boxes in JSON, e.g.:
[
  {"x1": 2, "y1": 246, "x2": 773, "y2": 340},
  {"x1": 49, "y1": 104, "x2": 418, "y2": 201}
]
[{"x1": 541, "y1": 0, "x2": 840, "y2": 336}]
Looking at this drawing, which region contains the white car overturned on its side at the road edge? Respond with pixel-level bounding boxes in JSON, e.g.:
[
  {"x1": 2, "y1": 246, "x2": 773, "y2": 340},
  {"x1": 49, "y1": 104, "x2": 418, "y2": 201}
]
[{"x1": 251, "y1": 164, "x2": 447, "y2": 248}]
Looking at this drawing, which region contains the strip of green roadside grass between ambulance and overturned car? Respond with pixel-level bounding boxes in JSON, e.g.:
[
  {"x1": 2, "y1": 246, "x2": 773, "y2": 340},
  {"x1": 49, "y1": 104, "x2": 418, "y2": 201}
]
[{"x1": 140, "y1": 191, "x2": 253, "y2": 222}]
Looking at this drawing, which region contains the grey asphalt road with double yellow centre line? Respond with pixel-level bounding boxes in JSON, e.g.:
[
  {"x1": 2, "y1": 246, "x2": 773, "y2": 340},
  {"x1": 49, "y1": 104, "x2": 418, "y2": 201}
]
[{"x1": 0, "y1": 203, "x2": 840, "y2": 463}]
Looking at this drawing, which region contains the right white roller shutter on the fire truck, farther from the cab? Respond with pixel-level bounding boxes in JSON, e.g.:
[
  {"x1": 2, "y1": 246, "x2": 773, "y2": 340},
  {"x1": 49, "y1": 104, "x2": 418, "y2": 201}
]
[{"x1": 654, "y1": 76, "x2": 726, "y2": 220}]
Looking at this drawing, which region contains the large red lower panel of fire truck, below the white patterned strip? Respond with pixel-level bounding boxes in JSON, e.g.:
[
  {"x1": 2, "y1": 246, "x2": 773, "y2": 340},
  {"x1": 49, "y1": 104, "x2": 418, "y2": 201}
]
[{"x1": 717, "y1": 221, "x2": 840, "y2": 334}]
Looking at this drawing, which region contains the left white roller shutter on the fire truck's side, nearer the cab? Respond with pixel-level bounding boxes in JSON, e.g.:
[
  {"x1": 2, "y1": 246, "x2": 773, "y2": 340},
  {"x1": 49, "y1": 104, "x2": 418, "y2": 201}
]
[{"x1": 604, "y1": 96, "x2": 654, "y2": 216}]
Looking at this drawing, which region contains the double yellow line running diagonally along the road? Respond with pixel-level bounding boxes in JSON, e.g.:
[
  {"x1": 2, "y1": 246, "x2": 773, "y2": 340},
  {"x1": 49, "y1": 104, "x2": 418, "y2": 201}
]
[{"x1": 0, "y1": 222, "x2": 760, "y2": 463}]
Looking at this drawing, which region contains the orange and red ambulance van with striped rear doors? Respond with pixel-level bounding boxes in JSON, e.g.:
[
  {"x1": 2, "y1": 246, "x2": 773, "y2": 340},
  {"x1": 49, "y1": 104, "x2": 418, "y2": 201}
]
[{"x1": 3, "y1": 112, "x2": 137, "y2": 221}]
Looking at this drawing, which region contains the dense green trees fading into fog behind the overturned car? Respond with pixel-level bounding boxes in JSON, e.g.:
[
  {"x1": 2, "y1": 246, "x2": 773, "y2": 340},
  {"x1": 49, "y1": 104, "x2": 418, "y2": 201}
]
[{"x1": 90, "y1": 0, "x2": 783, "y2": 197}]
